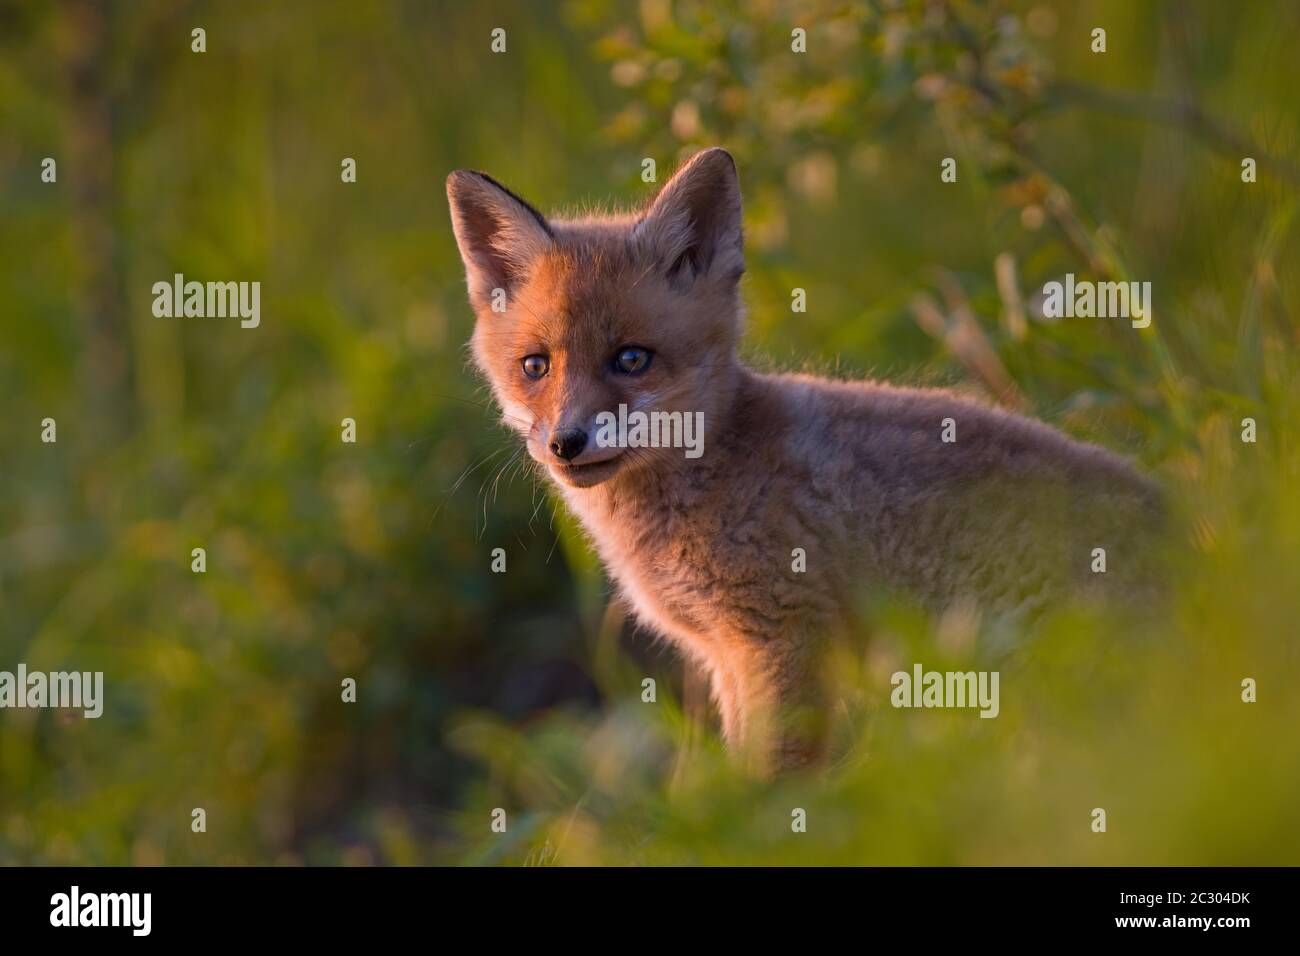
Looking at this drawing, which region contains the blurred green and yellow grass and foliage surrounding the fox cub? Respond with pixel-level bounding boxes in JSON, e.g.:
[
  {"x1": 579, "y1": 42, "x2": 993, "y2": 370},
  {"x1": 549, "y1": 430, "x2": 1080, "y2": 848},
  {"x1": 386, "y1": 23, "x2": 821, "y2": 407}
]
[{"x1": 0, "y1": 0, "x2": 1300, "y2": 865}]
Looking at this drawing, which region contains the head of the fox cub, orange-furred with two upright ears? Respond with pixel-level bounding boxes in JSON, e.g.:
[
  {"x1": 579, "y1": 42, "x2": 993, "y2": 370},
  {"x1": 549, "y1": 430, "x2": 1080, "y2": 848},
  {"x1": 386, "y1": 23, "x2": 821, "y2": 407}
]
[{"x1": 447, "y1": 148, "x2": 745, "y2": 488}]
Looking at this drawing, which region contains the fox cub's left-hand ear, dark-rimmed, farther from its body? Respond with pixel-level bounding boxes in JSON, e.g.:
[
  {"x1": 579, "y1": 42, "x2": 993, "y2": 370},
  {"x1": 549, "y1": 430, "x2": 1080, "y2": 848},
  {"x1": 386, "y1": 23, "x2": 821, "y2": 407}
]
[{"x1": 447, "y1": 169, "x2": 554, "y2": 307}]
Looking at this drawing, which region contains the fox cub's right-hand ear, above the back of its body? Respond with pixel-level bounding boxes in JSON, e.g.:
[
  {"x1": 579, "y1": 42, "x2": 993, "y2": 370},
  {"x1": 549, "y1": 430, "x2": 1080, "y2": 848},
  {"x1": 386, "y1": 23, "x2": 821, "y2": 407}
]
[{"x1": 633, "y1": 147, "x2": 745, "y2": 285}]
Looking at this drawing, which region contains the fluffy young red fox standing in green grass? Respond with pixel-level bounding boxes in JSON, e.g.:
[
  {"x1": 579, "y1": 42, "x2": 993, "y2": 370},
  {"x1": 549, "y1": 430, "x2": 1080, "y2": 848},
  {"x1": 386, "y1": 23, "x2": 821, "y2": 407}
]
[{"x1": 447, "y1": 148, "x2": 1160, "y2": 767}]
